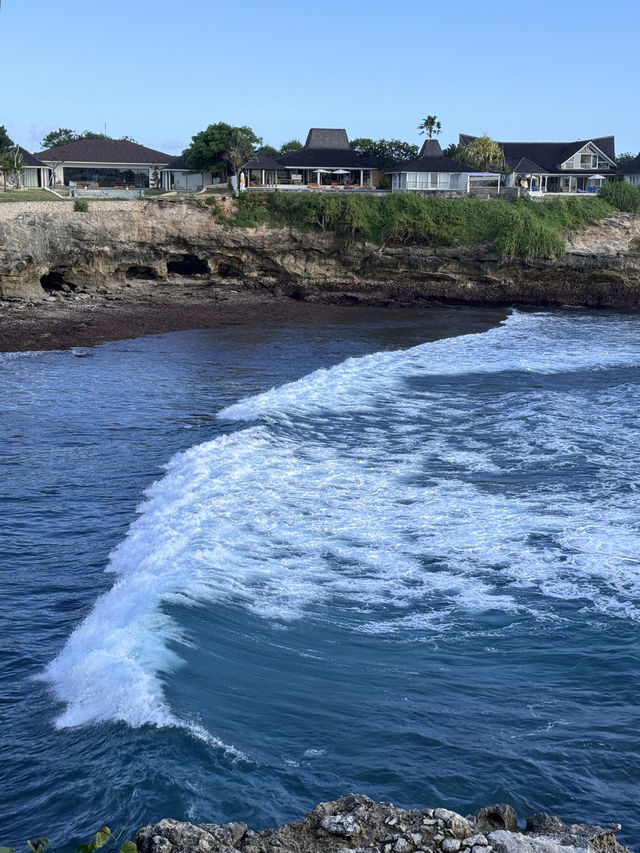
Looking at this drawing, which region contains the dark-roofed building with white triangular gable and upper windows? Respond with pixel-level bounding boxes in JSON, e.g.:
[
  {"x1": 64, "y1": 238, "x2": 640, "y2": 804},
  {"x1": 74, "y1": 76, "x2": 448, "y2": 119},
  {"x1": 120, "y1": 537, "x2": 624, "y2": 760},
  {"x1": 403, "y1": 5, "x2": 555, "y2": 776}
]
[{"x1": 460, "y1": 133, "x2": 617, "y2": 193}]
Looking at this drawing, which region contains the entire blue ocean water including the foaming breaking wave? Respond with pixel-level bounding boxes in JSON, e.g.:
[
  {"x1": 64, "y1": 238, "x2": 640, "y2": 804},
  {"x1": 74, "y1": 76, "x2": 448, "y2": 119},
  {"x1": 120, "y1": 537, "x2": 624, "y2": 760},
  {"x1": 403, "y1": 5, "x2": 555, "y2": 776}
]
[{"x1": 0, "y1": 309, "x2": 640, "y2": 851}]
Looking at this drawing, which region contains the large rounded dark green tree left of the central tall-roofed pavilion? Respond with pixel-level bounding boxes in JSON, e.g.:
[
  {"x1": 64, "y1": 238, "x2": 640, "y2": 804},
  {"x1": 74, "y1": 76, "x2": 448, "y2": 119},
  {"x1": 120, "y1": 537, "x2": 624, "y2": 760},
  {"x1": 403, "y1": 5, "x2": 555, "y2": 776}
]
[{"x1": 182, "y1": 121, "x2": 262, "y2": 177}]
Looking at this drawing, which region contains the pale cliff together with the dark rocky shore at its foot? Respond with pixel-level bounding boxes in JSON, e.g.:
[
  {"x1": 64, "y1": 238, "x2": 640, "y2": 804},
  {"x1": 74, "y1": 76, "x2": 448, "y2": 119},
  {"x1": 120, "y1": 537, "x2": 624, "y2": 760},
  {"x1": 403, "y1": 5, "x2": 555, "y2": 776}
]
[{"x1": 0, "y1": 199, "x2": 640, "y2": 351}]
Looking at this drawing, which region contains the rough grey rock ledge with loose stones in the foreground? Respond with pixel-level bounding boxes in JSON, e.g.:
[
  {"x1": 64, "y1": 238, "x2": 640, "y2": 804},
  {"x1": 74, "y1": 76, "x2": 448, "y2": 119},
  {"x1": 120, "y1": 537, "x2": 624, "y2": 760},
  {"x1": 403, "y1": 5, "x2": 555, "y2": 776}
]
[{"x1": 136, "y1": 794, "x2": 630, "y2": 853}]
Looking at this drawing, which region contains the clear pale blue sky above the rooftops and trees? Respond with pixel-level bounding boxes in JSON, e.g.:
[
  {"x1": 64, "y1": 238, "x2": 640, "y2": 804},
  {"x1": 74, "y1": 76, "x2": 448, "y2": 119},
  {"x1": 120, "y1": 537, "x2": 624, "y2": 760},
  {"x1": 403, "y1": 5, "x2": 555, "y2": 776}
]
[{"x1": 0, "y1": 0, "x2": 640, "y2": 154}]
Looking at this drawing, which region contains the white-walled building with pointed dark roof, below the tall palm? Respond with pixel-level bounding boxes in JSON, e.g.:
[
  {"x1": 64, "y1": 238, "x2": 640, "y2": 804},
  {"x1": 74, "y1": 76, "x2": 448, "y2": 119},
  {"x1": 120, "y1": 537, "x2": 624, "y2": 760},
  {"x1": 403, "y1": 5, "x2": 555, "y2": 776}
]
[{"x1": 388, "y1": 139, "x2": 488, "y2": 194}]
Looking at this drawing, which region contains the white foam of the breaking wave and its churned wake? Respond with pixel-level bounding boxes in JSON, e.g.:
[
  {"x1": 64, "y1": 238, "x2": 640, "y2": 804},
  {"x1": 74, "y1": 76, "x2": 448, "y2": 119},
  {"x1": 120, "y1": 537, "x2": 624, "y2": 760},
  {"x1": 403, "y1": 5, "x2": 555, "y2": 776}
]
[{"x1": 46, "y1": 314, "x2": 640, "y2": 728}]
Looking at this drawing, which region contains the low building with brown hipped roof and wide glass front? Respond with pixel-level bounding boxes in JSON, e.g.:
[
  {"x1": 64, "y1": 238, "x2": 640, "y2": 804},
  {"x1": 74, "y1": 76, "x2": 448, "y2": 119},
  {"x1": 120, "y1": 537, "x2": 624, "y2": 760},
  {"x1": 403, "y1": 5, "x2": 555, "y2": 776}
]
[{"x1": 36, "y1": 139, "x2": 175, "y2": 189}]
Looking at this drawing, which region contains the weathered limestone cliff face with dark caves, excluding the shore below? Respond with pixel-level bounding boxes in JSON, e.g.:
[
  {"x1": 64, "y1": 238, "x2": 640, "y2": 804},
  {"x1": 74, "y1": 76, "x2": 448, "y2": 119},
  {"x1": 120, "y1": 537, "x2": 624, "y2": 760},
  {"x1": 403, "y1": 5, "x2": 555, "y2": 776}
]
[{"x1": 0, "y1": 200, "x2": 640, "y2": 308}]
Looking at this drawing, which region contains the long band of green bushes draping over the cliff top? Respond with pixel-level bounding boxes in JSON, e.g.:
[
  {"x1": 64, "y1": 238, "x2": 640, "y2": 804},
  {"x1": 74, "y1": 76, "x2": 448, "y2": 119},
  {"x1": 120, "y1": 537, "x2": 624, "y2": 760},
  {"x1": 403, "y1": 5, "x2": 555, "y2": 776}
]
[{"x1": 222, "y1": 191, "x2": 612, "y2": 258}]
